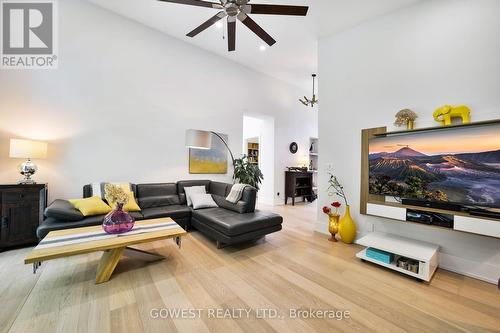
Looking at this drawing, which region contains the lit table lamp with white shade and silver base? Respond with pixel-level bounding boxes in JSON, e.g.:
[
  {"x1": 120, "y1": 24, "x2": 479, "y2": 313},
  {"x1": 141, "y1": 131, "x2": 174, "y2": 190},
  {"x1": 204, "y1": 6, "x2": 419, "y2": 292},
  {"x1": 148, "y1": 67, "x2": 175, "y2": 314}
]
[{"x1": 9, "y1": 139, "x2": 47, "y2": 184}]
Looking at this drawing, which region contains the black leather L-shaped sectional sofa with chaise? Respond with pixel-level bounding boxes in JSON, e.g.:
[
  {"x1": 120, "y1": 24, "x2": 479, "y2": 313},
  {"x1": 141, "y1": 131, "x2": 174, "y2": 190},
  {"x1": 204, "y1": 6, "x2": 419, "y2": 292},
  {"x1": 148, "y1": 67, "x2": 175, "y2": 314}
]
[{"x1": 37, "y1": 180, "x2": 283, "y2": 247}]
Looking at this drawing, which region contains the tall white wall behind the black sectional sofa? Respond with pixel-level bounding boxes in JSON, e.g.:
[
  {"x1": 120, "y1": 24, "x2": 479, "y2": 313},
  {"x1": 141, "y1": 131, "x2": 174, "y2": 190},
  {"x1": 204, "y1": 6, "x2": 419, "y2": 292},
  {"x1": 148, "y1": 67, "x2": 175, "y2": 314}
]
[{"x1": 0, "y1": 0, "x2": 316, "y2": 199}]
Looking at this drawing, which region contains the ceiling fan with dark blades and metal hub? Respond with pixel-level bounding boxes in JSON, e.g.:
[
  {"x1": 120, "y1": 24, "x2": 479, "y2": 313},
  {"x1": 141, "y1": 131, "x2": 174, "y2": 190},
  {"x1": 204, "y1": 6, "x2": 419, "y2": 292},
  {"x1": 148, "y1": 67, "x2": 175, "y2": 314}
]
[{"x1": 158, "y1": 0, "x2": 309, "y2": 51}]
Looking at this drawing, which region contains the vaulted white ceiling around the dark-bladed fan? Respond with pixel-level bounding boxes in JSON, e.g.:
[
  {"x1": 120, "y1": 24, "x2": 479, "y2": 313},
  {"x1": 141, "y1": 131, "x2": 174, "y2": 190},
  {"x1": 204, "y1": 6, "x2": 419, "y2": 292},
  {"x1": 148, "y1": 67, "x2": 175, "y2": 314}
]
[{"x1": 89, "y1": 0, "x2": 421, "y2": 89}]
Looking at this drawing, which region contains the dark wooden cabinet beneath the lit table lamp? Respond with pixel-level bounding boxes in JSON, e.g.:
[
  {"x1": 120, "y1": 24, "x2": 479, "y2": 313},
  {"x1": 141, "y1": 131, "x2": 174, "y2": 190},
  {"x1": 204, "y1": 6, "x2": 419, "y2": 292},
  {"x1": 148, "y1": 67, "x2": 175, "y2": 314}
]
[{"x1": 0, "y1": 184, "x2": 47, "y2": 250}]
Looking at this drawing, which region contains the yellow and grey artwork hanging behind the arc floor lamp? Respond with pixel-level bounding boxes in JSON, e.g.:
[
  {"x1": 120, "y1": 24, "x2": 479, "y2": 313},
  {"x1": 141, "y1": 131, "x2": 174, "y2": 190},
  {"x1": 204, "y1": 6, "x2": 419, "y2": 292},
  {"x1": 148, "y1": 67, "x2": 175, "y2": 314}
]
[{"x1": 189, "y1": 133, "x2": 228, "y2": 174}]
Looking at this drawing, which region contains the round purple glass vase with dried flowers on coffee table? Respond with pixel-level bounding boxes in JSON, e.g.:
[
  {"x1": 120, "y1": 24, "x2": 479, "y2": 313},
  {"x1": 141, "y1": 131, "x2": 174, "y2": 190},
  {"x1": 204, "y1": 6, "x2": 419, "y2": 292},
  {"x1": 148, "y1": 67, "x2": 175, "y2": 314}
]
[{"x1": 102, "y1": 184, "x2": 134, "y2": 234}]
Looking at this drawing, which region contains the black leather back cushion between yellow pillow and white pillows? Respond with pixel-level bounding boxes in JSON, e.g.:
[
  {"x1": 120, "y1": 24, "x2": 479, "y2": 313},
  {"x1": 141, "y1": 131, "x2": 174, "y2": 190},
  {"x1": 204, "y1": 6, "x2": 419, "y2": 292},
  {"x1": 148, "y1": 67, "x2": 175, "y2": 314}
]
[{"x1": 137, "y1": 183, "x2": 180, "y2": 209}]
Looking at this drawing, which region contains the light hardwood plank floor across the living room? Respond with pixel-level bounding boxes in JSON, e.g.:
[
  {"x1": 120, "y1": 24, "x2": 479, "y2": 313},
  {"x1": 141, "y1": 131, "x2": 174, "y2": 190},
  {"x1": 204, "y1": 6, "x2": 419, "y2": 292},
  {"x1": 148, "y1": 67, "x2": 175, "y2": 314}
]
[{"x1": 0, "y1": 204, "x2": 500, "y2": 333}]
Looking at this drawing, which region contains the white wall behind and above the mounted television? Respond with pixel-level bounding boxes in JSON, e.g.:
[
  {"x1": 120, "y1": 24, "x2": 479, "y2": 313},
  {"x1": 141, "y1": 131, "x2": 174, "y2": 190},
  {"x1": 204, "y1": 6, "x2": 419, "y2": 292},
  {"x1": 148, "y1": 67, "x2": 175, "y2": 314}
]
[{"x1": 318, "y1": 0, "x2": 500, "y2": 283}]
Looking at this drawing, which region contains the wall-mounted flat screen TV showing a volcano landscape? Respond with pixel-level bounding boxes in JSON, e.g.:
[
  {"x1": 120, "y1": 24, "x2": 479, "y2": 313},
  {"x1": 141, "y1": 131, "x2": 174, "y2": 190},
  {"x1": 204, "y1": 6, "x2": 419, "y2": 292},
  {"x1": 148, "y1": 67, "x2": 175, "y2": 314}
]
[{"x1": 369, "y1": 124, "x2": 500, "y2": 208}]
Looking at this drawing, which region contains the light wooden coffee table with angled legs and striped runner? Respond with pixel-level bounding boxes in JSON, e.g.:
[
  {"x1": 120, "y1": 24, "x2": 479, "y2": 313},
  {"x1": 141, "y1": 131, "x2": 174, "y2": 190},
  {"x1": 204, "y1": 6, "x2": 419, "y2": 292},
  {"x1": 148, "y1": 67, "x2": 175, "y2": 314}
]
[{"x1": 24, "y1": 218, "x2": 186, "y2": 284}]
